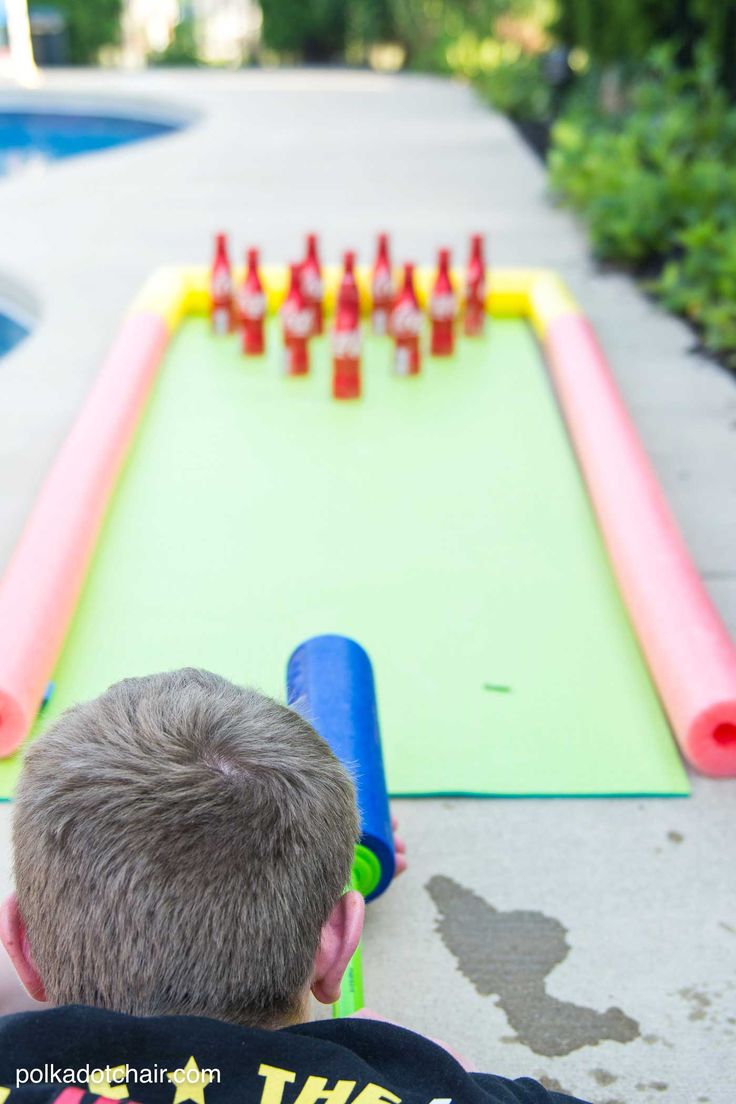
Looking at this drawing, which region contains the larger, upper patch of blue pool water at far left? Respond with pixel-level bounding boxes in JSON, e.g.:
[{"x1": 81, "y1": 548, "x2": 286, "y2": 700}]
[{"x1": 0, "y1": 110, "x2": 178, "y2": 176}]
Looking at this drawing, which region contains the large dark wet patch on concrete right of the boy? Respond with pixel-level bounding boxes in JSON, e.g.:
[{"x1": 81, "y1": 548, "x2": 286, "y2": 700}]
[{"x1": 427, "y1": 874, "x2": 639, "y2": 1058}]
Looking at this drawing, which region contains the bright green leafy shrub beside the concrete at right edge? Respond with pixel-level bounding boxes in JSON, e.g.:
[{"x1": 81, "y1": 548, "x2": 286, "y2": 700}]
[{"x1": 548, "y1": 49, "x2": 736, "y2": 365}]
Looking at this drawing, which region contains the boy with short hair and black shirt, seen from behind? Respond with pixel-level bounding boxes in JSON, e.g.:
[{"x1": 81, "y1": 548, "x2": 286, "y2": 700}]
[{"x1": 0, "y1": 669, "x2": 587, "y2": 1104}]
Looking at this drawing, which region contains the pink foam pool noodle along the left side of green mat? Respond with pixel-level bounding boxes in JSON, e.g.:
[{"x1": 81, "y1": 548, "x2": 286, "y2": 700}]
[{"x1": 0, "y1": 312, "x2": 168, "y2": 756}]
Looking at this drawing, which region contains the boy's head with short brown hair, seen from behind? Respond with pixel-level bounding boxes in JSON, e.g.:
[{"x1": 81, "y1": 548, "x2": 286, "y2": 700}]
[{"x1": 2, "y1": 669, "x2": 363, "y2": 1026}]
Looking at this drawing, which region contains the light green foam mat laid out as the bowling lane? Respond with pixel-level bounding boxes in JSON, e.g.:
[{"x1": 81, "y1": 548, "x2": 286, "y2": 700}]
[{"x1": 0, "y1": 319, "x2": 687, "y2": 796}]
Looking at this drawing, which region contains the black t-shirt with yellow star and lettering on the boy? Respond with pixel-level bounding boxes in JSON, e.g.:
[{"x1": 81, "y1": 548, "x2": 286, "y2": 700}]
[{"x1": 0, "y1": 1005, "x2": 580, "y2": 1104}]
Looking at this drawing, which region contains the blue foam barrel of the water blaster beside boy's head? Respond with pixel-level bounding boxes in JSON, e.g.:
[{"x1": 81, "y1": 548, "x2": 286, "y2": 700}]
[{"x1": 286, "y1": 635, "x2": 395, "y2": 901}]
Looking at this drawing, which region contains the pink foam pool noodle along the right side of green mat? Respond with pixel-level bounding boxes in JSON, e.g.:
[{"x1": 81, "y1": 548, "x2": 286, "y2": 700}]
[{"x1": 544, "y1": 314, "x2": 736, "y2": 775}]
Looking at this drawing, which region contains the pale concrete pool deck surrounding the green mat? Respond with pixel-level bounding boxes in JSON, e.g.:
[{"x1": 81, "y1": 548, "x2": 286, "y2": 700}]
[{"x1": 0, "y1": 72, "x2": 736, "y2": 1104}]
